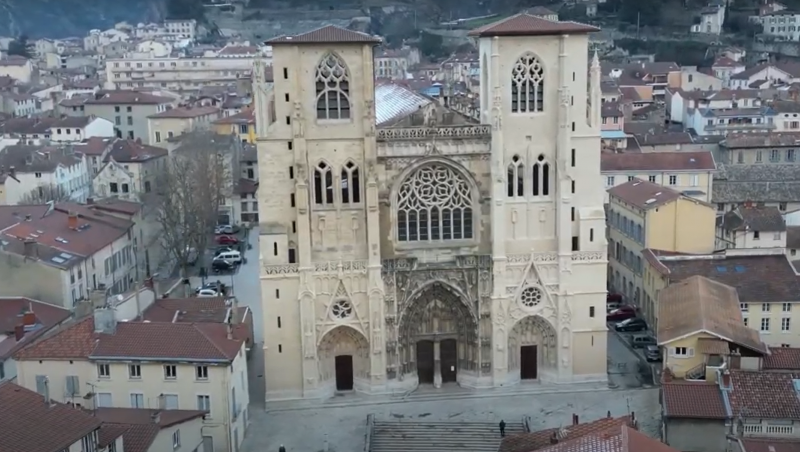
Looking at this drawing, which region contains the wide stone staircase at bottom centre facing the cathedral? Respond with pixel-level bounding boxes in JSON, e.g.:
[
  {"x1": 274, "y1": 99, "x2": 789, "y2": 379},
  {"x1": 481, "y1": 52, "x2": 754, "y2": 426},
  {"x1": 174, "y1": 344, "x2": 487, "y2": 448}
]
[{"x1": 367, "y1": 420, "x2": 525, "y2": 452}]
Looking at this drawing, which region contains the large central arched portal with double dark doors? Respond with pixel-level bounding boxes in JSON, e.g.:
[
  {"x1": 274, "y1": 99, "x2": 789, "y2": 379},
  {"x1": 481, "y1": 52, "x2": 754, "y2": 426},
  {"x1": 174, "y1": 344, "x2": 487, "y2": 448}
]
[{"x1": 399, "y1": 282, "x2": 478, "y2": 386}]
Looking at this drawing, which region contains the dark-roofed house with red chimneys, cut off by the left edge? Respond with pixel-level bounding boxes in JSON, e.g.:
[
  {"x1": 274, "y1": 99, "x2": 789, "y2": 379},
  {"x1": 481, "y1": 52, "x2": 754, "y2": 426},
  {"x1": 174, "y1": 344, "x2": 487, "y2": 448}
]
[{"x1": 0, "y1": 297, "x2": 72, "y2": 382}]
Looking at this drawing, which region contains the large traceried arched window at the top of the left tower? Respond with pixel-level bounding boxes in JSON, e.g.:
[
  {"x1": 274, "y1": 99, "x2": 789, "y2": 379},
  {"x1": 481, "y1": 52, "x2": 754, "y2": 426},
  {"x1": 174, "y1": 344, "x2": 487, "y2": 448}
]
[{"x1": 315, "y1": 53, "x2": 350, "y2": 119}]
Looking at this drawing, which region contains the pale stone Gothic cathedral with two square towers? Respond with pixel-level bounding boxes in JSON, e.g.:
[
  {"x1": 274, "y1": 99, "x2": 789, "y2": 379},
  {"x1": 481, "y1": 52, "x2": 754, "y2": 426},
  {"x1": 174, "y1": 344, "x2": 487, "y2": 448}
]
[{"x1": 253, "y1": 14, "x2": 607, "y2": 401}]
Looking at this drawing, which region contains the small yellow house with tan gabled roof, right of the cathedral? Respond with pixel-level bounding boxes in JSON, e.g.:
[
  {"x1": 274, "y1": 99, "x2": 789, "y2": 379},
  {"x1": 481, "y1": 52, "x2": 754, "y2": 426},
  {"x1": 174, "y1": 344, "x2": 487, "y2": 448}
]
[{"x1": 657, "y1": 276, "x2": 769, "y2": 381}]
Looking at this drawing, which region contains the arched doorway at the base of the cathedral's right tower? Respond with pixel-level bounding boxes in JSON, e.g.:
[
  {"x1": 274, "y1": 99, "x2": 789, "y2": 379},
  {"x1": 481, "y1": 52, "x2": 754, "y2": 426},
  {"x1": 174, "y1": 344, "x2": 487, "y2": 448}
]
[{"x1": 508, "y1": 315, "x2": 558, "y2": 381}]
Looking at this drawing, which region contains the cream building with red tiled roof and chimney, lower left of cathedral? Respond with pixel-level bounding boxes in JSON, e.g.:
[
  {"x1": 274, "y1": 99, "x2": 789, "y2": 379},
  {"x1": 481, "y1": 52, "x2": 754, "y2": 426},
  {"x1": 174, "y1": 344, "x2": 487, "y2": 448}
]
[{"x1": 16, "y1": 308, "x2": 249, "y2": 452}]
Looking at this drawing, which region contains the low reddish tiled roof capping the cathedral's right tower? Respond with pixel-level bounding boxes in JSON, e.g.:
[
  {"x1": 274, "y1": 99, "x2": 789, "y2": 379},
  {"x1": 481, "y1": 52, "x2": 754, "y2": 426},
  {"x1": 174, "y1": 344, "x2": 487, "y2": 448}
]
[{"x1": 469, "y1": 13, "x2": 600, "y2": 38}]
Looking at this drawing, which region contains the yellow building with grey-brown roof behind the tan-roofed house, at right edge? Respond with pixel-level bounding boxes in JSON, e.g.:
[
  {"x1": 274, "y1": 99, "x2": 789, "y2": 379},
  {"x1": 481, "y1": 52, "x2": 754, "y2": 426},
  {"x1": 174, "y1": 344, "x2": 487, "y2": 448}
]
[{"x1": 642, "y1": 249, "x2": 800, "y2": 346}]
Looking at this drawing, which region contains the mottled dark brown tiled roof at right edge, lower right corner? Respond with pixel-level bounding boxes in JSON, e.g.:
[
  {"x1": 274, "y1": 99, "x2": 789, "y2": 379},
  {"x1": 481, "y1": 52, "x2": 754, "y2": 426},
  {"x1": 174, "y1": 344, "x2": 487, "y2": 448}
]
[{"x1": 728, "y1": 369, "x2": 800, "y2": 420}]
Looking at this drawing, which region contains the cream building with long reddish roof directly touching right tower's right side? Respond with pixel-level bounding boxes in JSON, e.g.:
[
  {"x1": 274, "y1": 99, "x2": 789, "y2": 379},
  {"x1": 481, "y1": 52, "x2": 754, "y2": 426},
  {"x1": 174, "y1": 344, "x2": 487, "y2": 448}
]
[{"x1": 600, "y1": 151, "x2": 717, "y2": 202}]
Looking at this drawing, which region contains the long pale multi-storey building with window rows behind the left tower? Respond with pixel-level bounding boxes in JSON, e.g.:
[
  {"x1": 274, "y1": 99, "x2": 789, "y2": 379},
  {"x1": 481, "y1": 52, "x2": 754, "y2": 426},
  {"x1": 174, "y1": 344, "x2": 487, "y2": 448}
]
[{"x1": 105, "y1": 46, "x2": 264, "y2": 91}]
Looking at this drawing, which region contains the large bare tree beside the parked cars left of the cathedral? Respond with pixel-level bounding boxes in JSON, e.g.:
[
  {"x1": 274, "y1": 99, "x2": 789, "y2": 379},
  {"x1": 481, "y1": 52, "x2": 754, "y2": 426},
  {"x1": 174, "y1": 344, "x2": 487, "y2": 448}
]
[{"x1": 151, "y1": 134, "x2": 233, "y2": 296}]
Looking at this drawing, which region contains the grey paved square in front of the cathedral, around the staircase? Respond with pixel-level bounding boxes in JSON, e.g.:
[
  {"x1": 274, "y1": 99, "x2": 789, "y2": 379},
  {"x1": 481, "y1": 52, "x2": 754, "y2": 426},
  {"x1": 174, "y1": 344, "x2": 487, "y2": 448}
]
[{"x1": 241, "y1": 389, "x2": 660, "y2": 452}]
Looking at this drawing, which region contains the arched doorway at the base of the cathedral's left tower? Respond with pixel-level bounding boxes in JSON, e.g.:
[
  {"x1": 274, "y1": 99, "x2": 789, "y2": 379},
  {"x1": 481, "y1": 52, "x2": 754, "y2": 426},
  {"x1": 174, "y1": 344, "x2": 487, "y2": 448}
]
[{"x1": 318, "y1": 325, "x2": 370, "y2": 393}]
